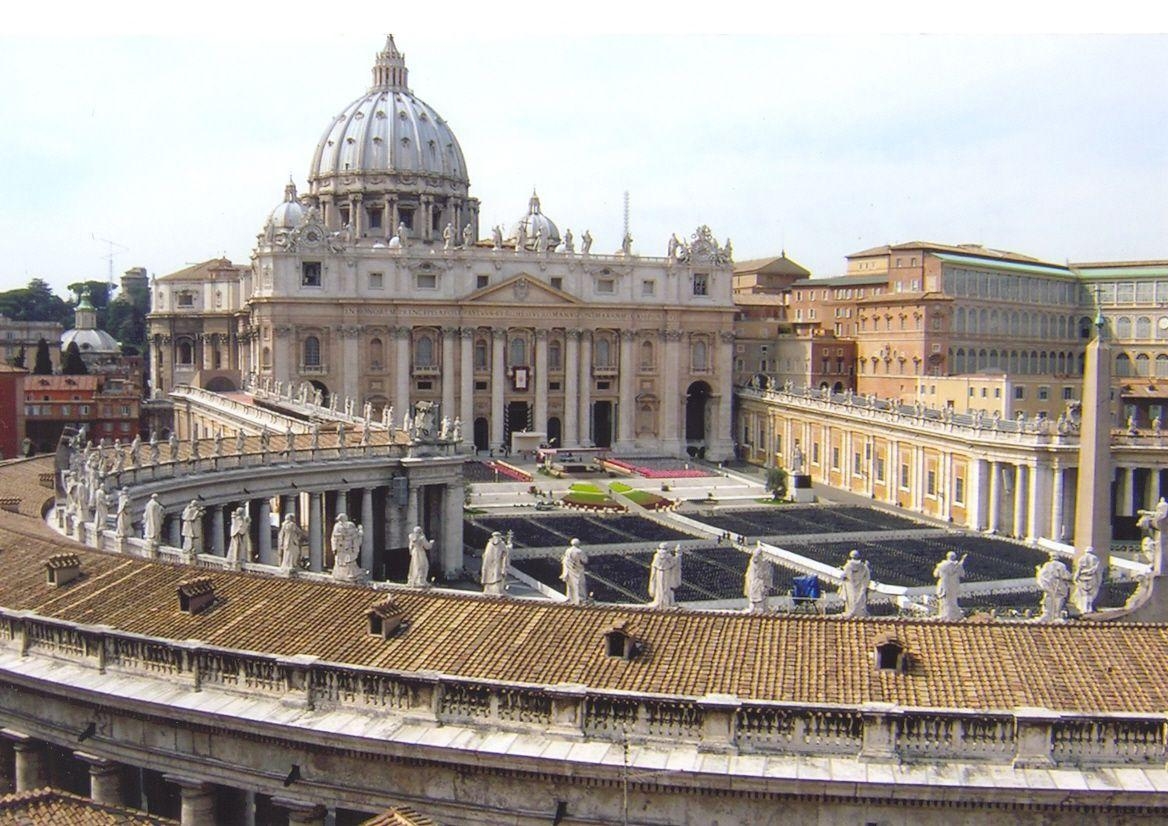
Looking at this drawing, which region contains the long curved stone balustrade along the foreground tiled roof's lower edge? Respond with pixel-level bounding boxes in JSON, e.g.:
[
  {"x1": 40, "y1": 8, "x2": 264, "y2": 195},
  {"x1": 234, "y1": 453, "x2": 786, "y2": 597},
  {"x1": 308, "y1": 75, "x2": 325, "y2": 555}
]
[{"x1": 0, "y1": 609, "x2": 1168, "y2": 768}]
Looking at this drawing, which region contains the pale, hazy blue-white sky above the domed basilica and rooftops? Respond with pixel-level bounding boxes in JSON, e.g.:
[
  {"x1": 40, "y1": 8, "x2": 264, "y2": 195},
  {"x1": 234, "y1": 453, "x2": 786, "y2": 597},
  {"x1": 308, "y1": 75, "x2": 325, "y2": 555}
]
[{"x1": 0, "y1": 0, "x2": 1168, "y2": 292}]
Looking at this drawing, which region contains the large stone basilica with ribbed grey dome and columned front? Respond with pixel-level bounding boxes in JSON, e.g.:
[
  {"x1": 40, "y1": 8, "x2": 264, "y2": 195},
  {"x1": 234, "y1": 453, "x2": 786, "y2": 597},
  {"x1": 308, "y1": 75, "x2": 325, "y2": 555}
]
[{"x1": 151, "y1": 39, "x2": 735, "y2": 459}]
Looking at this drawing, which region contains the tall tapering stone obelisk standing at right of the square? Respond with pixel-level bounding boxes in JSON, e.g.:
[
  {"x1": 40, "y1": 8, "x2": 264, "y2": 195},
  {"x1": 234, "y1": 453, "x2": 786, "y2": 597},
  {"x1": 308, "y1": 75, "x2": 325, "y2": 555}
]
[{"x1": 1075, "y1": 312, "x2": 1111, "y2": 571}]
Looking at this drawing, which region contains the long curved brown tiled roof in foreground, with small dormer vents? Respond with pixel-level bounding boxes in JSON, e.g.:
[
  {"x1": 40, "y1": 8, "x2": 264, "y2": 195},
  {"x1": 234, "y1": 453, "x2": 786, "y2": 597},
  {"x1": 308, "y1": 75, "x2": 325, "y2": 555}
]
[{"x1": 0, "y1": 504, "x2": 1168, "y2": 713}]
